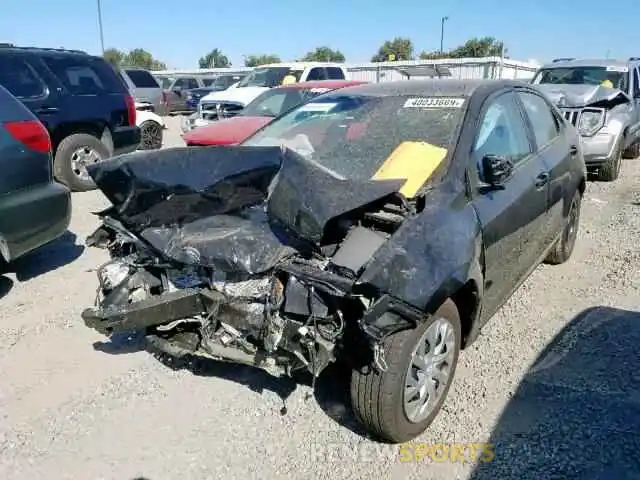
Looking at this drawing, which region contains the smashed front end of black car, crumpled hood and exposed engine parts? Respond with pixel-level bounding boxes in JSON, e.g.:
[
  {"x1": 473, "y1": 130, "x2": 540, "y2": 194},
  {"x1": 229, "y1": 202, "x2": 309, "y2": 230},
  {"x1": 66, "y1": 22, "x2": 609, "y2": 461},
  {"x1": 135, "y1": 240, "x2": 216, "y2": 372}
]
[{"x1": 83, "y1": 147, "x2": 430, "y2": 376}]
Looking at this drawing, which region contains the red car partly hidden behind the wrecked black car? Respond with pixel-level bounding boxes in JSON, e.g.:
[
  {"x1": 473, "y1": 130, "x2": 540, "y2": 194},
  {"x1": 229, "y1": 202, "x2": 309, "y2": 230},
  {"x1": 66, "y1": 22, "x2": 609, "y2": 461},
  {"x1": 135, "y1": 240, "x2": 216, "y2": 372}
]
[{"x1": 182, "y1": 80, "x2": 367, "y2": 147}]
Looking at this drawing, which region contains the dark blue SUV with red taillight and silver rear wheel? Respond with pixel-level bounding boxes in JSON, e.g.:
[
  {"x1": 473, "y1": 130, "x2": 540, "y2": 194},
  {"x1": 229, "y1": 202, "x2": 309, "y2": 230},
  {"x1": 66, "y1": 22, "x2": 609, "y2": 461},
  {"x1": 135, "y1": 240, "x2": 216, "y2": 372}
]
[{"x1": 0, "y1": 44, "x2": 140, "y2": 191}]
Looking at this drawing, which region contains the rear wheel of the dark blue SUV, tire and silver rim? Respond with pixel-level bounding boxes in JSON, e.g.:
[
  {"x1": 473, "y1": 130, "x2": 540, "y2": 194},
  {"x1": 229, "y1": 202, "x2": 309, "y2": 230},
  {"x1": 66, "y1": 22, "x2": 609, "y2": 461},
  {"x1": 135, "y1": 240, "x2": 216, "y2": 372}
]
[{"x1": 53, "y1": 133, "x2": 109, "y2": 192}]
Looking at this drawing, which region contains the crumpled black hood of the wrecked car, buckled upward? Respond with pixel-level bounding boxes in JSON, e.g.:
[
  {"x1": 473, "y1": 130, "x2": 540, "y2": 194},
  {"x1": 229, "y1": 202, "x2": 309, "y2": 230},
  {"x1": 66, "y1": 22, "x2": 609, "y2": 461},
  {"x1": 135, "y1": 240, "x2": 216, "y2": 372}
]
[{"x1": 88, "y1": 146, "x2": 405, "y2": 275}]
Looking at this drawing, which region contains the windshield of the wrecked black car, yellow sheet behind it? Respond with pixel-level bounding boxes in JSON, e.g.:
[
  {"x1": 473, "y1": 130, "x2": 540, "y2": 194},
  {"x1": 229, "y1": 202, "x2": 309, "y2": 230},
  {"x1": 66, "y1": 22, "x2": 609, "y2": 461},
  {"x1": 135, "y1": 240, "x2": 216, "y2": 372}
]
[{"x1": 243, "y1": 93, "x2": 465, "y2": 180}]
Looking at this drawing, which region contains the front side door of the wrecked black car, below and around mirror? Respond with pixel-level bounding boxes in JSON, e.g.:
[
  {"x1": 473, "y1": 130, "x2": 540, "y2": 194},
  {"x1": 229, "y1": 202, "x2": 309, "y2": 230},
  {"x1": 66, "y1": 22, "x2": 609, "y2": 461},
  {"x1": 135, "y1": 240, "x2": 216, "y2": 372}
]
[{"x1": 468, "y1": 91, "x2": 548, "y2": 321}]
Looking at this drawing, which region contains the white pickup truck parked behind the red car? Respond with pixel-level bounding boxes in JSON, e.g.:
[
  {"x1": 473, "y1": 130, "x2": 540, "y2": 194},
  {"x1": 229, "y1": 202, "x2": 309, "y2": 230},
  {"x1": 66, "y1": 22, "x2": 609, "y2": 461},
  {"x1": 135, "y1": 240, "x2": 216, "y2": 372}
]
[{"x1": 182, "y1": 62, "x2": 349, "y2": 132}]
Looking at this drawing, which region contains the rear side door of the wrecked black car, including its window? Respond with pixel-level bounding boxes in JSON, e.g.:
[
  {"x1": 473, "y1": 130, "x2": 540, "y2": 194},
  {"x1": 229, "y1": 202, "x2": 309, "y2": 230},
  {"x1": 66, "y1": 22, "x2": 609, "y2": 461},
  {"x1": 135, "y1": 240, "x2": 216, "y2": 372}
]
[{"x1": 518, "y1": 90, "x2": 579, "y2": 247}]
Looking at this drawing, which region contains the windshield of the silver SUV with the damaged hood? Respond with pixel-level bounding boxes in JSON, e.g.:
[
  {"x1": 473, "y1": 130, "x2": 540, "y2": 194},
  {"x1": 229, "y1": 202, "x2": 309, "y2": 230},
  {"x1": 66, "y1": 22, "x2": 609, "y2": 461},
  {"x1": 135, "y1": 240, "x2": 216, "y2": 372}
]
[{"x1": 533, "y1": 66, "x2": 629, "y2": 91}]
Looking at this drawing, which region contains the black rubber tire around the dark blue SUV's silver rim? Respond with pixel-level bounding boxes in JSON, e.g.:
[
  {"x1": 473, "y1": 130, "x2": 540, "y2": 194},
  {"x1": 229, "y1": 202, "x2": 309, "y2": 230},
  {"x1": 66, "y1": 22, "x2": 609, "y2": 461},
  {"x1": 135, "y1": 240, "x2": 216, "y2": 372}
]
[{"x1": 53, "y1": 133, "x2": 110, "y2": 192}]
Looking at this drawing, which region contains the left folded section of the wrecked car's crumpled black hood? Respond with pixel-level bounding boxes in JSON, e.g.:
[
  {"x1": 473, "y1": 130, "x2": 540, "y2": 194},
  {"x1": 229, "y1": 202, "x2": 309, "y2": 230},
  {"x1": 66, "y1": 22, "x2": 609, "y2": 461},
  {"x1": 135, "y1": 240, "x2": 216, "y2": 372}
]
[{"x1": 87, "y1": 147, "x2": 284, "y2": 233}]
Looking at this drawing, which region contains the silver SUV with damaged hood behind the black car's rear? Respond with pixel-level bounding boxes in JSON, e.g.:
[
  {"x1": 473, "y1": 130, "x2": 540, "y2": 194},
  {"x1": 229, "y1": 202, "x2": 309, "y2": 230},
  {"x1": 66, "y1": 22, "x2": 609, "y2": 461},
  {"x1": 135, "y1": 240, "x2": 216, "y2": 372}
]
[{"x1": 532, "y1": 57, "x2": 640, "y2": 181}]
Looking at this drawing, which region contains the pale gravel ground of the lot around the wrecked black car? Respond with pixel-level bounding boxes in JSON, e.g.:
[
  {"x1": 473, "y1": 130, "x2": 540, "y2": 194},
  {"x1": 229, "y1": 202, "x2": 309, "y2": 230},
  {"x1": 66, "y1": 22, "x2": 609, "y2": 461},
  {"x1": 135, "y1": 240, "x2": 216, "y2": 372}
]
[{"x1": 0, "y1": 118, "x2": 640, "y2": 480}]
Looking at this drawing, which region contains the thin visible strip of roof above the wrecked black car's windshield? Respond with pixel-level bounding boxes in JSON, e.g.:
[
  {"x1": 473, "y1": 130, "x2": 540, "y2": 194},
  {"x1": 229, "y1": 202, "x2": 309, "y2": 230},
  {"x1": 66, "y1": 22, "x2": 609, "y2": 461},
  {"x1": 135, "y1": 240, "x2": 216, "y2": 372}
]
[{"x1": 322, "y1": 79, "x2": 529, "y2": 97}]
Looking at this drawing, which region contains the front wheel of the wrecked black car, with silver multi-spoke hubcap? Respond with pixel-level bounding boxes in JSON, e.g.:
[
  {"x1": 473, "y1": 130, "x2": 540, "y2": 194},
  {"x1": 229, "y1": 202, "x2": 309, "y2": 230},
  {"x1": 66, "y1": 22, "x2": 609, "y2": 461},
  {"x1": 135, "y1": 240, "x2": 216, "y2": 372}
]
[{"x1": 351, "y1": 300, "x2": 462, "y2": 443}]
